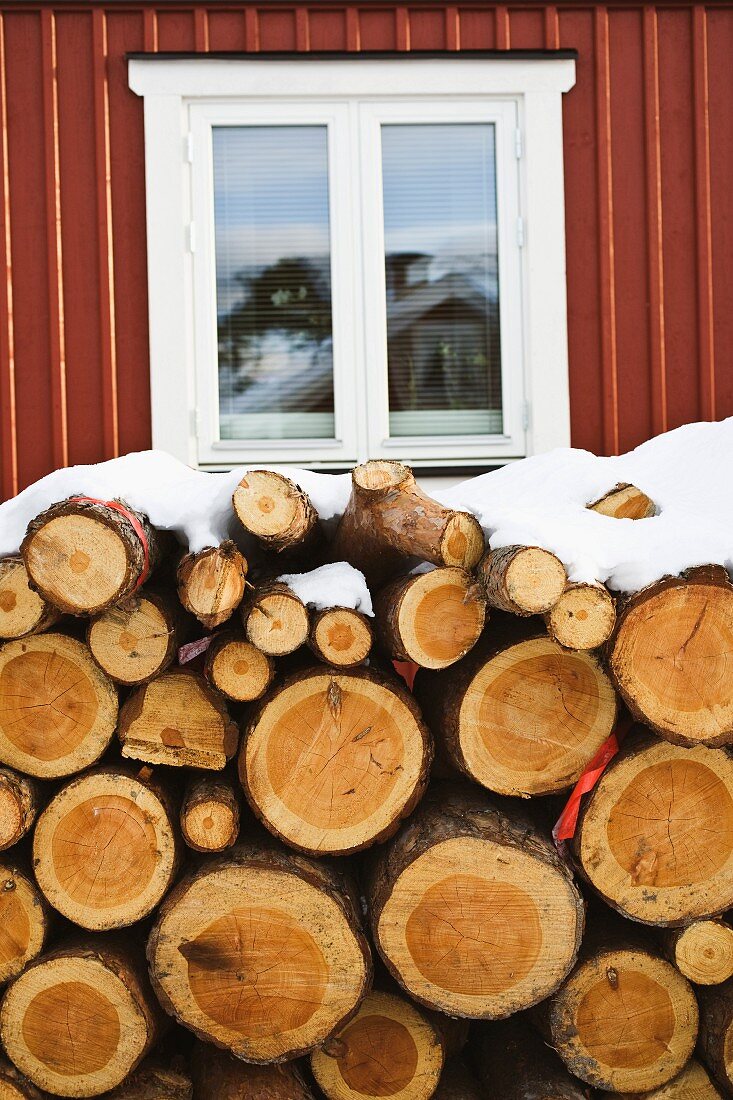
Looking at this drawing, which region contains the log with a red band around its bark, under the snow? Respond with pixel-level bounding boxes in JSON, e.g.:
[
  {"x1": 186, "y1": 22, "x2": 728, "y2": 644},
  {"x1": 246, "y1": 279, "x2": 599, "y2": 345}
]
[{"x1": 21, "y1": 497, "x2": 162, "y2": 615}]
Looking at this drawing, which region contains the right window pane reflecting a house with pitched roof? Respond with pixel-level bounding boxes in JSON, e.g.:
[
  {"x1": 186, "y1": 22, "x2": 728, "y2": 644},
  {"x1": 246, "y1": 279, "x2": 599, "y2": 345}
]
[{"x1": 382, "y1": 123, "x2": 502, "y2": 437}]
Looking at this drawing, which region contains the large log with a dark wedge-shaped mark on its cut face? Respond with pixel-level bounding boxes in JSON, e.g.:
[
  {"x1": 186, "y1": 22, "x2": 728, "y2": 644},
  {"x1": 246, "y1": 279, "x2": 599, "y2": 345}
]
[{"x1": 147, "y1": 845, "x2": 371, "y2": 1064}]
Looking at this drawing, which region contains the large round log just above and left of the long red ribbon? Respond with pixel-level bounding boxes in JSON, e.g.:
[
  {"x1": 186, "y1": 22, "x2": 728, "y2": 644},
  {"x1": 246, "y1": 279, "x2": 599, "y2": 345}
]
[{"x1": 415, "y1": 616, "x2": 616, "y2": 798}]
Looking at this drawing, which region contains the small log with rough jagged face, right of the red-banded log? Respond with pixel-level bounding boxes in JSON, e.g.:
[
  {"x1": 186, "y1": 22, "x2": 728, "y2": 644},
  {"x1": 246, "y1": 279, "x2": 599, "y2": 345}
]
[{"x1": 177, "y1": 541, "x2": 247, "y2": 630}]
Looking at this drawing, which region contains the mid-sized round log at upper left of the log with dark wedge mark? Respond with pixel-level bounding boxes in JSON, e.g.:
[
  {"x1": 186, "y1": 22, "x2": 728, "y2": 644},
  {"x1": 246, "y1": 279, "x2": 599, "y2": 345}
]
[{"x1": 33, "y1": 767, "x2": 178, "y2": 932}]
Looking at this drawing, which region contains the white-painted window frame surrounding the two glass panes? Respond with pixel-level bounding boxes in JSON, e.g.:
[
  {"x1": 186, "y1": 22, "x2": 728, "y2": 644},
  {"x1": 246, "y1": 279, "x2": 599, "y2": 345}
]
[{"x1": 129, "y1": 54, "x2": 575, "y2": 469}]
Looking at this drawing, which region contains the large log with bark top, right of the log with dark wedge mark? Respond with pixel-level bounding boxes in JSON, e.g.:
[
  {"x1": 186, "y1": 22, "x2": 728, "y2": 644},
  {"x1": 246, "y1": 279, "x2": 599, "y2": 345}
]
[{"x1": 365, "y1": 788, "x2": 583, "y2": 1020}]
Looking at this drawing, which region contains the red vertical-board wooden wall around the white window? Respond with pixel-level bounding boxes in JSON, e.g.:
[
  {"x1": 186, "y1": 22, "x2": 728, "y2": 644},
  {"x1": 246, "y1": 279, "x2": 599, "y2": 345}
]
[{"x1": 0, "y1": 0, "x2": 733, "y2": 496}]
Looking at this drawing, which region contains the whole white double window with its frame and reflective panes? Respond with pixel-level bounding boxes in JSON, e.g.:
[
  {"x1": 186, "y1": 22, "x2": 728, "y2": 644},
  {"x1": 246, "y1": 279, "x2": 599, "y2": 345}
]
[{"x1": 130, "y1": 55, "x2": 573, "y2": 468}]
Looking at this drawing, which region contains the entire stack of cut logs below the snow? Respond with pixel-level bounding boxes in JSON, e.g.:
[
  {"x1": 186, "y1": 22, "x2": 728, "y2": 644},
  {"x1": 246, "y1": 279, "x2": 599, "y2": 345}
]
[{"x1": 0, "y1": 461, "x2": 733, "y2": 1100}]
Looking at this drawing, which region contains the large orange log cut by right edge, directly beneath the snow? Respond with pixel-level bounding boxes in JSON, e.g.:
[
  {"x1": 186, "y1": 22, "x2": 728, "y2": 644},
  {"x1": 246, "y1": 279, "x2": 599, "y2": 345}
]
[{"x1": 610, "y1": 565, "x2": 733, "y2": 746}]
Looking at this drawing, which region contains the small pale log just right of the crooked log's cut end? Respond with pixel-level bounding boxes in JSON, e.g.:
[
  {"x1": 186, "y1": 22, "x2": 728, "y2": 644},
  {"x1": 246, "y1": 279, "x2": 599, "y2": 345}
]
[{"x1": 478, "y1": 546, "x2": 568, "y2": 616}]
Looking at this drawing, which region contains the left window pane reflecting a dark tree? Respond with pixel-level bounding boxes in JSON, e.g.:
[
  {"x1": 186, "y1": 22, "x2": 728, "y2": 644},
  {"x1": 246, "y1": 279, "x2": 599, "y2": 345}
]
[{"x1": 212, "y1": 125, "x2": 335, "y2": 439}]
